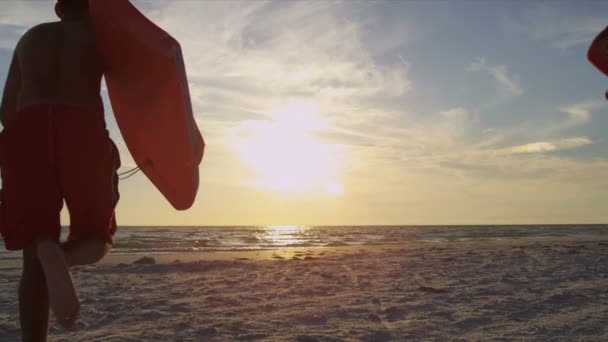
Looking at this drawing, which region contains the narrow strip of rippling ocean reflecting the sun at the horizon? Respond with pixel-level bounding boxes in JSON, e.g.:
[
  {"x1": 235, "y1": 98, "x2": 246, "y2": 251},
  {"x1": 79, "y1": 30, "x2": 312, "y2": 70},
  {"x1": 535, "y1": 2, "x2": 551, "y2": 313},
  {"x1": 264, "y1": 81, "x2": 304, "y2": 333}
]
[{"x1": 0, "y1": 225, "x2": 608, "y2": 258}]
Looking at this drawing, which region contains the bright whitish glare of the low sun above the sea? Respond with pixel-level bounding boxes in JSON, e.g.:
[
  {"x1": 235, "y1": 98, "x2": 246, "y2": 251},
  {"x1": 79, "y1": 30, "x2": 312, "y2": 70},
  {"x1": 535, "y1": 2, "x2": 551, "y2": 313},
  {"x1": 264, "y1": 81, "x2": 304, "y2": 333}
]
[{"x1": 237, "y1": 101, "x2": 344, "y2": 196}]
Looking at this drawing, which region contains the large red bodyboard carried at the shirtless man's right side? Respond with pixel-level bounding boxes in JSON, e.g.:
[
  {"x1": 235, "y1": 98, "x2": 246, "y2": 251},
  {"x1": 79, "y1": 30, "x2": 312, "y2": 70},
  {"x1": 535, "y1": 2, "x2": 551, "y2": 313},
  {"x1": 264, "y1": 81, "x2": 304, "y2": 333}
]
[{"x1": 89, "y1": 0, "x2": 205, "y2": 210}]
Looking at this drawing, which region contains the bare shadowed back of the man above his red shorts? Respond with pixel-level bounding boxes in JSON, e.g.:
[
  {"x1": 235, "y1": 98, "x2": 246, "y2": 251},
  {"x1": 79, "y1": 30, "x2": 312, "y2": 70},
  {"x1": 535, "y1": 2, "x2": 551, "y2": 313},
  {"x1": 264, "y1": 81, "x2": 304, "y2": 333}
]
[{"x1": 16, "y1": 17, "x2": 103, "y2": 113}]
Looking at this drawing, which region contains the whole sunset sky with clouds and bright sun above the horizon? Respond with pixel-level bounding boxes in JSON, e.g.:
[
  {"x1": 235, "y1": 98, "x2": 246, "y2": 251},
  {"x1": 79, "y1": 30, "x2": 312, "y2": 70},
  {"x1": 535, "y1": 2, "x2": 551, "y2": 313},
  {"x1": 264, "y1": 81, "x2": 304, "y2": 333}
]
[{"x1": 0, "y1": 0, "x2": 608, "y2": 225}]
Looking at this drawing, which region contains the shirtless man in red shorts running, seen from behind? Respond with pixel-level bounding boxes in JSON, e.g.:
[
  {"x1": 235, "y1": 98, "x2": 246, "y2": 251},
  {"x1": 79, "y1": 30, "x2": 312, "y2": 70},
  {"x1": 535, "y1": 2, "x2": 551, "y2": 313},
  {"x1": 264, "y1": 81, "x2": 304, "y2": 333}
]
[{"x1": 0, "y1": 0, "x2": 120, "y2": 341}]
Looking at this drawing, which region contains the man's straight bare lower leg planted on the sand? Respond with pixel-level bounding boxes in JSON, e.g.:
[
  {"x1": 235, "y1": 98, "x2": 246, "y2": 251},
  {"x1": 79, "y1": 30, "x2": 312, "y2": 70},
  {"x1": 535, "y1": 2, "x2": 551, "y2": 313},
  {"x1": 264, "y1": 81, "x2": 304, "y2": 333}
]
[{"x1": 19, "y1": 244, "x2": 50, "y2": 342}]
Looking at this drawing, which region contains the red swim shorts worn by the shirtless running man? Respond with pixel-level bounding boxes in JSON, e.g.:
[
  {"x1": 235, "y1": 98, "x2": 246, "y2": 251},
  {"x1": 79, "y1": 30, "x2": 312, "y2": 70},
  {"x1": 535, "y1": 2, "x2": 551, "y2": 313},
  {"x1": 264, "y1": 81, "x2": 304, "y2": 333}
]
[{"x1": 0, "y1": 104, "x2": 120, "y2": 250}]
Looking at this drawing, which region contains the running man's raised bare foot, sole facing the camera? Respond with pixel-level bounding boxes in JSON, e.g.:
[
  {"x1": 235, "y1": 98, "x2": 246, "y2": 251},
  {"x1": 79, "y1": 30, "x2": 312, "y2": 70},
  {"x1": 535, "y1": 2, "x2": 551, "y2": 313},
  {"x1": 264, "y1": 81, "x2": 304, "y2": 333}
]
[{"x1": 36, "y1": 240, "x2": 80, "y2": 330}]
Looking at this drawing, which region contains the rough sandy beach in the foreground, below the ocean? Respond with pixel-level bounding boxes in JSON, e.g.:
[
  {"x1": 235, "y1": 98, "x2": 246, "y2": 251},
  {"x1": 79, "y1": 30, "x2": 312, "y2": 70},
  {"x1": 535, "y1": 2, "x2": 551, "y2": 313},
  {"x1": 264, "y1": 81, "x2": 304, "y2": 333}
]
[{"x1": 0, "y1": 239, "x2": 608, "y2": 342}]
